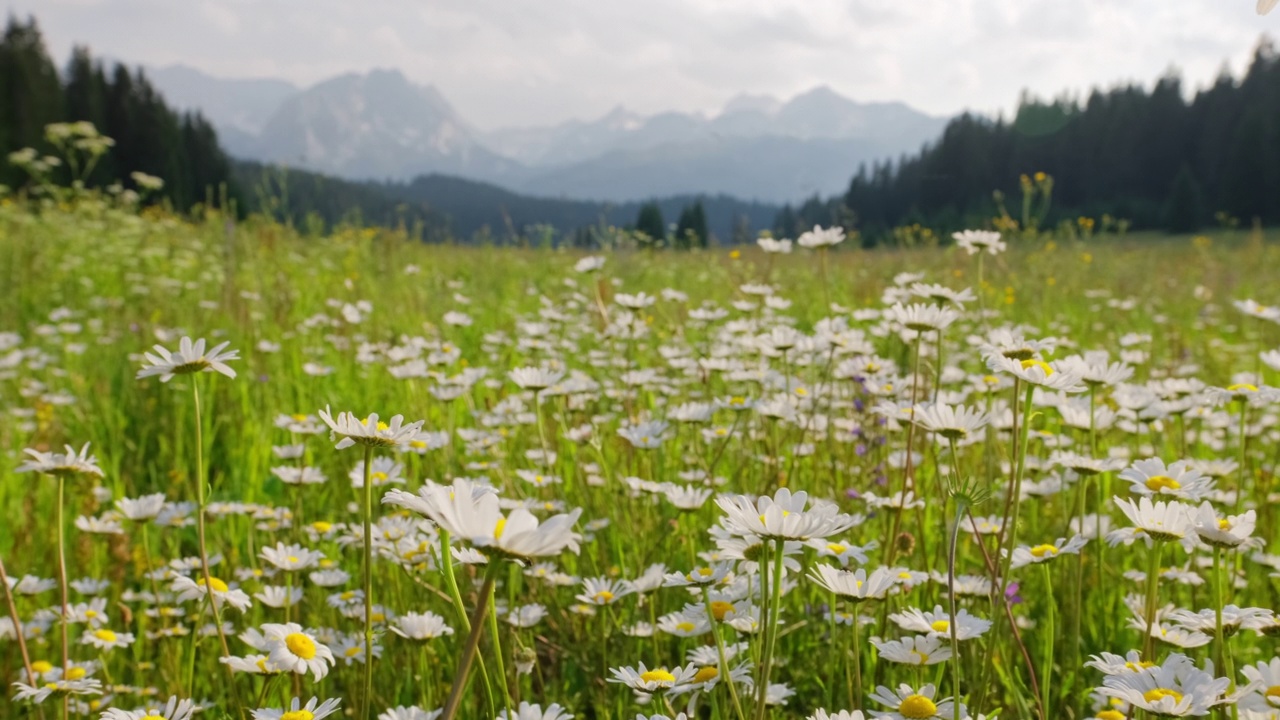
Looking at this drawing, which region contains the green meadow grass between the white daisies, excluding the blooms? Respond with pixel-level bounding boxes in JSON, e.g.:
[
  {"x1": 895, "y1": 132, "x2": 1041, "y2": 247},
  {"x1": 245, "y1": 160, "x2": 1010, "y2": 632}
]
[{"x1": 0, "y1": 199, "x2": 1280, "y2": 719}]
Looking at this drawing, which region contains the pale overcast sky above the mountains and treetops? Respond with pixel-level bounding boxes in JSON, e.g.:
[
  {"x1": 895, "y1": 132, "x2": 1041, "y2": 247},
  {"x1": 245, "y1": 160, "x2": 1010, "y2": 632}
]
[{"x1": 10, "y1": 0, "x2": 1280, "y2": 129}]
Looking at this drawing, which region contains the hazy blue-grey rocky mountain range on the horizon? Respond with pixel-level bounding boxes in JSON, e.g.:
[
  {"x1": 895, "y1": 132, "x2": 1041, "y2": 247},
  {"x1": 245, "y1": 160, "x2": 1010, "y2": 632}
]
[{"x1": 147, "y1": 65, "x2": 947, "y2": 202}]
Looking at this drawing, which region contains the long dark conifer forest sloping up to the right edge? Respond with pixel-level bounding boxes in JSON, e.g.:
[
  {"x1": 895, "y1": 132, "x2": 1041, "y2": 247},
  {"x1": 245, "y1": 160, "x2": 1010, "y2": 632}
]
[{"x1": 774, "y1": 40, "x2": 1280, "y2": 238}]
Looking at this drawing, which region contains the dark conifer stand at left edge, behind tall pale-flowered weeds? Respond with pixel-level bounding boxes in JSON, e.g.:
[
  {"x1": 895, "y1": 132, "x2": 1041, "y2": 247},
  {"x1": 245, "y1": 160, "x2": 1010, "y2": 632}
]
[{"x1": 0, "y1": 17, "x2": 236, "y2": 210}]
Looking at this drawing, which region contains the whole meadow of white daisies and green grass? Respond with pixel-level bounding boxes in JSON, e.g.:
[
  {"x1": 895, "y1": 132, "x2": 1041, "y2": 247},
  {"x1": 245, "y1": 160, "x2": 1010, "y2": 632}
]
[{"x1": 0, "y1": 196, "x2": 1280, "y2": 720}]
